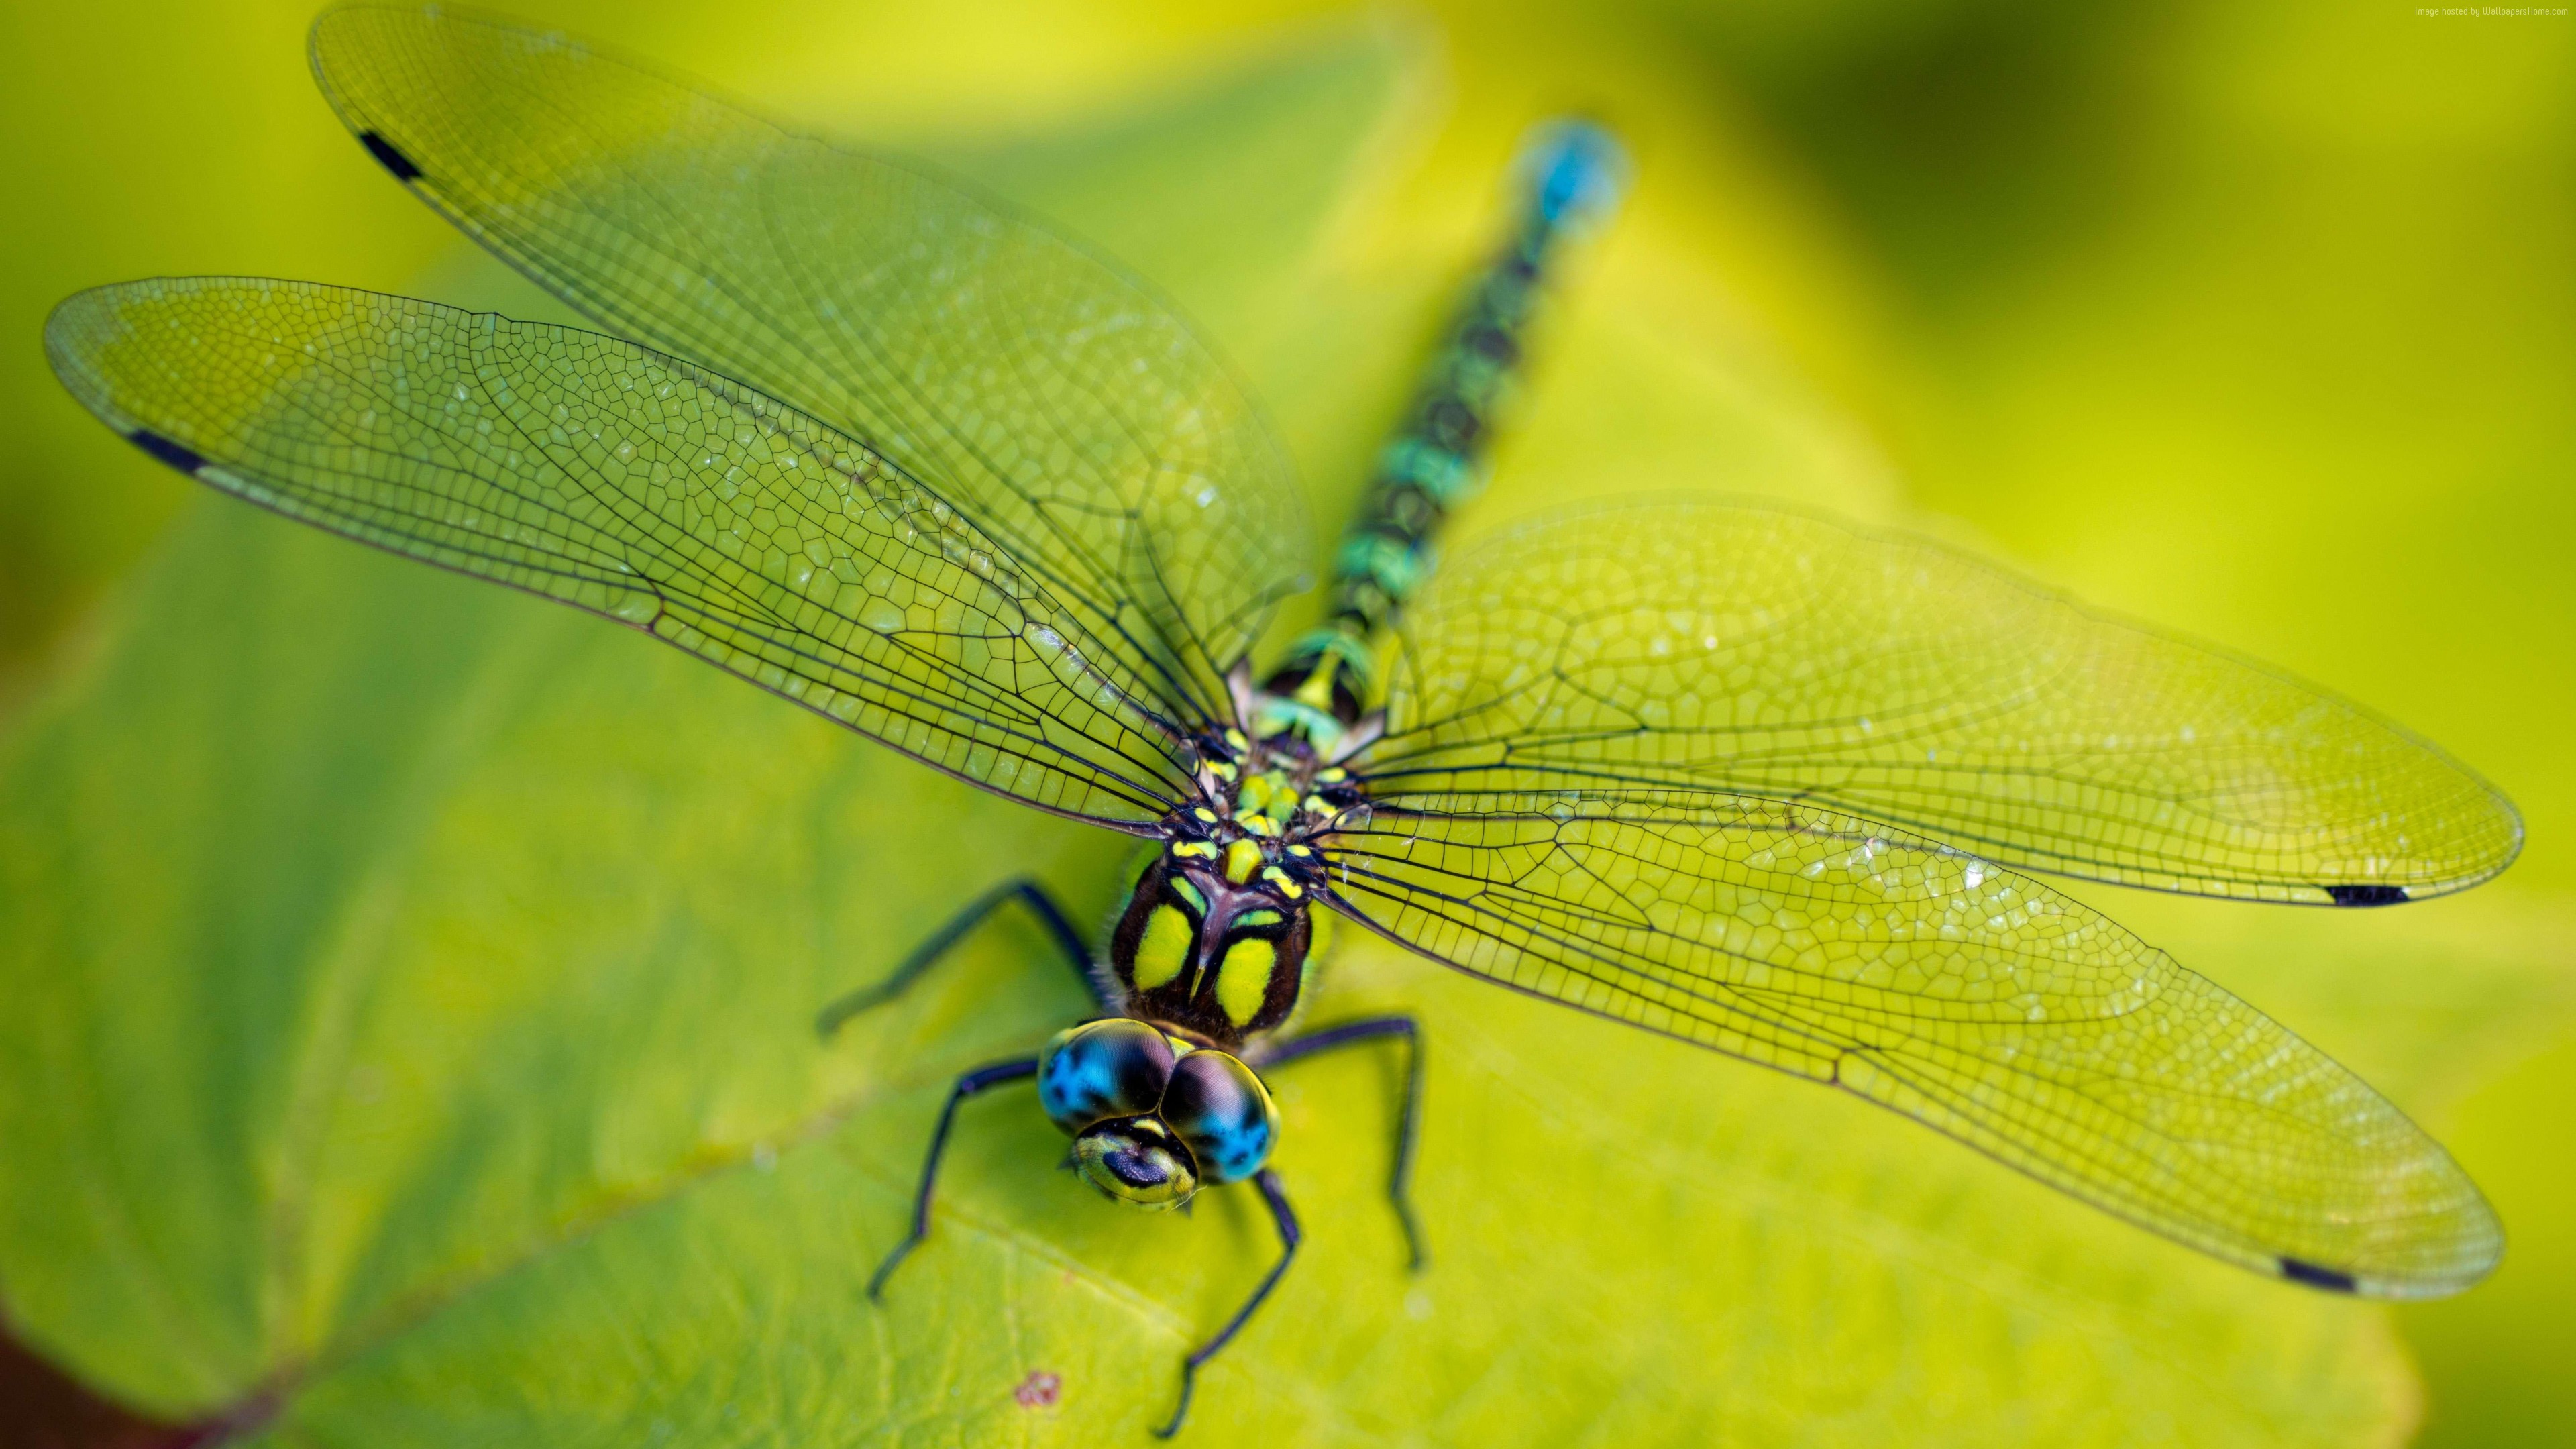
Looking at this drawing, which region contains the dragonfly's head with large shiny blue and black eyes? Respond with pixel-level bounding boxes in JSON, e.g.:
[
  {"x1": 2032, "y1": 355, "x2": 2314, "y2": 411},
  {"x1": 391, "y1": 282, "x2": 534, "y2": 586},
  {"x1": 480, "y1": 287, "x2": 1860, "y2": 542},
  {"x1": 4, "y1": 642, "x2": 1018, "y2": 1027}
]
[{"x1": 1038, "y1": 1016, "x2": 1278, "y2": 1207}]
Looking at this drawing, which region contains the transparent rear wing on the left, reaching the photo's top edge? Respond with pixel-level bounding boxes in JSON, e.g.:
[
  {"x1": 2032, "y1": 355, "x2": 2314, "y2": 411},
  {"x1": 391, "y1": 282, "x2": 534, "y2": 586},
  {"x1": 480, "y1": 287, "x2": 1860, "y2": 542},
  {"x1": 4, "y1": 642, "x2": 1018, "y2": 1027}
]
[{"x1": 312, "y1": 5, "x2": 1309, "y2": 716}]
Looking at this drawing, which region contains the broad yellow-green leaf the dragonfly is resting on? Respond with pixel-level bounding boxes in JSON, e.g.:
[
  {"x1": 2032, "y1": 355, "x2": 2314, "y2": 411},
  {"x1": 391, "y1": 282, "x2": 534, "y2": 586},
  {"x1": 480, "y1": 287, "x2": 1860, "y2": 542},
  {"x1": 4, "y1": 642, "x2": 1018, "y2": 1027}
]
[{"x1": 0, "y1": 14, "x2": 2535, "y2": 1446}]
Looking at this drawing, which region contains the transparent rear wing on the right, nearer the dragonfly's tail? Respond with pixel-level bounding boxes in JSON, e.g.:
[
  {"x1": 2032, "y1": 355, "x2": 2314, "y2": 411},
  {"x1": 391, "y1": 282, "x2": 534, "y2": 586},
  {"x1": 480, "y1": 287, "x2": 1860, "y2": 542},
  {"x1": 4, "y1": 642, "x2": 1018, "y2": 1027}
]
[{"x1": 1368, "y1": 502, "x2": 2522, "y2": 905}]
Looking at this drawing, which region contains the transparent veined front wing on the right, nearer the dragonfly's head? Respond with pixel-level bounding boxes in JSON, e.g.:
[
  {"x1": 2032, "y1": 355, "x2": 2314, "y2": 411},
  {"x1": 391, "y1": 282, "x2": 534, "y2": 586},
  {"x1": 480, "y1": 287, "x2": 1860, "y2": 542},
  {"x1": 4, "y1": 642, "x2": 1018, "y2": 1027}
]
[{"x1": 1308, "y1": 792, "x2": 2502, "y2": 1297}]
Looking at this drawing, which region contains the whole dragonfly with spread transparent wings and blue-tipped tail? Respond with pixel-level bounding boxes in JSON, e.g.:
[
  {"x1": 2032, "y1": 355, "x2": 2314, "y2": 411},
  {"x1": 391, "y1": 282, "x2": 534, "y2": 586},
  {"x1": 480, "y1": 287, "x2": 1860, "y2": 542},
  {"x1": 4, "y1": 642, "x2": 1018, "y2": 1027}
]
[{"x1": 46, "y1": 5, "x2": 2522, "y2": 1434}]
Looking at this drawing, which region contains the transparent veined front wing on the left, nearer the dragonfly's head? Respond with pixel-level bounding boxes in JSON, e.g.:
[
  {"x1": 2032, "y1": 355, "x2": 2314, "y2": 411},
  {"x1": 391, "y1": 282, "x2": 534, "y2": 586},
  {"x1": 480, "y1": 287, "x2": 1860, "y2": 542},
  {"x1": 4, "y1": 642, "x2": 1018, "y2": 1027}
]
[{"x1": 46, "y1": 278, "x2": 1187, "y2": 830}]
